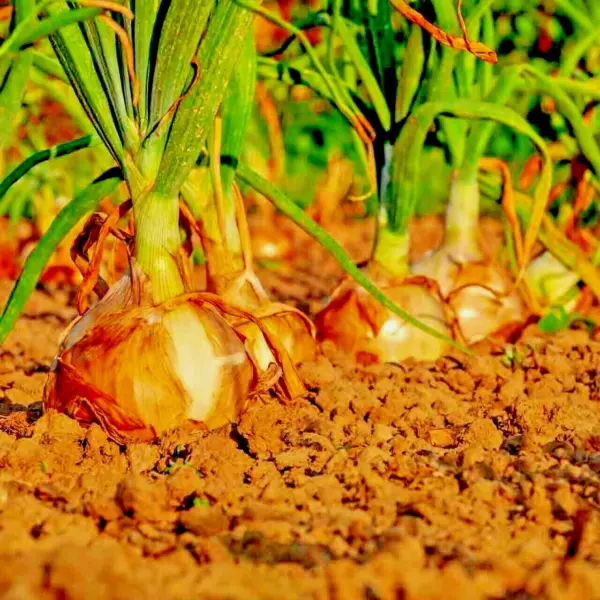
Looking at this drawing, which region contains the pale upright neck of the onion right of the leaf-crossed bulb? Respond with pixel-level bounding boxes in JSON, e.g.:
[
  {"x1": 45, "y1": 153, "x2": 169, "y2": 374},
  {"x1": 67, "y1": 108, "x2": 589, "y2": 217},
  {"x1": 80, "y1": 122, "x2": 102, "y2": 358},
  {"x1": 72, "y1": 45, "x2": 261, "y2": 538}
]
[{"x1": 444, "y1": 171, "x2": 481, "y2": 260}]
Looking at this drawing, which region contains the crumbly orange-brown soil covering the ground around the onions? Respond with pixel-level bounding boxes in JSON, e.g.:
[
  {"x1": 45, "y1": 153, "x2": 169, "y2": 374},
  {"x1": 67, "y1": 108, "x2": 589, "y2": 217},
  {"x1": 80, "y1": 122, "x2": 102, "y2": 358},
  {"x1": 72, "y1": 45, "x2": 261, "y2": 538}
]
[{"x1": 0, "y1": 219, "x2": 600, "y2": 600}]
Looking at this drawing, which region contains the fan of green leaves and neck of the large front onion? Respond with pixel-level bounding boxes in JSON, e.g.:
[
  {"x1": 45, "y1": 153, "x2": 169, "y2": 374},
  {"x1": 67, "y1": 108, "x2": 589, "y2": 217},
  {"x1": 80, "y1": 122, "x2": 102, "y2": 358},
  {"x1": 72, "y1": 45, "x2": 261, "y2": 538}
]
[{"x1": 0, "y1": 0, "x2": 252, "y2": 337}]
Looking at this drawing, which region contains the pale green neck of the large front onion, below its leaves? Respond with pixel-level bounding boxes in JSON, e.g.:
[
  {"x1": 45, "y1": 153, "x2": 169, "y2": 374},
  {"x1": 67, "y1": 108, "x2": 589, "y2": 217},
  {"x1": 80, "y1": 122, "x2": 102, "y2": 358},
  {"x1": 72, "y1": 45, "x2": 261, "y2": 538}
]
[{"x1": 133, "y1": 191, "x2": 185, "y2": 304}]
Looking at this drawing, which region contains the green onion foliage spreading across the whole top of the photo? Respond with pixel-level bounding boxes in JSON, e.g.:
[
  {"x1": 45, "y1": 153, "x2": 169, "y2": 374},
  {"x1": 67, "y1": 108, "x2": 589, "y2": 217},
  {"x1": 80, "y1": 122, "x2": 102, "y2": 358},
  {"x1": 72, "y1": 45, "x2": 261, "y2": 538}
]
[{"x1": 0, "y1": 0, "x2": 600, "y2": 344}]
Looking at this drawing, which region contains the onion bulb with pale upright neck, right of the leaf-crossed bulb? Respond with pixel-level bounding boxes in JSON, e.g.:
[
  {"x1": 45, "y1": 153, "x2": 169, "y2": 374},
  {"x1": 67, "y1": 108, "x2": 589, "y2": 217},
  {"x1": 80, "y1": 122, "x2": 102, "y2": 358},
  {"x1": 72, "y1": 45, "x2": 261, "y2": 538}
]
[{"x1": 411, "y1": 175, "x2": 525, "y2": 344}]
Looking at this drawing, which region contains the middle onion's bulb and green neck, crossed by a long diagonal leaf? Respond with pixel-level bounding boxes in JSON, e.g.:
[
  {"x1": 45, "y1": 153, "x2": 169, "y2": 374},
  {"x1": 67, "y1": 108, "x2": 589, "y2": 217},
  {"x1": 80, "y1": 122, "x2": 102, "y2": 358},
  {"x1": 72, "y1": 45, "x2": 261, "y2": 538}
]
[{"x1": 315, "y1": 137, "x2": 452, "y2": 363}]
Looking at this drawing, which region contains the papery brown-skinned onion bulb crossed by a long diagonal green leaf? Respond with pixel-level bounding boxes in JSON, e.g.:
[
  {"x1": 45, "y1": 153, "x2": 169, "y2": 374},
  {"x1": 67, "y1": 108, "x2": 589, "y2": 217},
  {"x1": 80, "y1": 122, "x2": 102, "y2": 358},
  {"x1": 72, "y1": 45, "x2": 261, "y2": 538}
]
[{"x1": 315, "y1": 282, "x2": 451, "y2": 364}]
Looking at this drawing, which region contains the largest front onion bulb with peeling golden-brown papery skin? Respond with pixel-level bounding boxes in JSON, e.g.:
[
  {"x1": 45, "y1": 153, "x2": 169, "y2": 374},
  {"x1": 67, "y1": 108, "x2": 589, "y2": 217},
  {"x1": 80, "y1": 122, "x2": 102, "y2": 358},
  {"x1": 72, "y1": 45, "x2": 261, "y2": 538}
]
[{"x1": 44, "y1": 270, "x2": 304, "y2": 441}]
